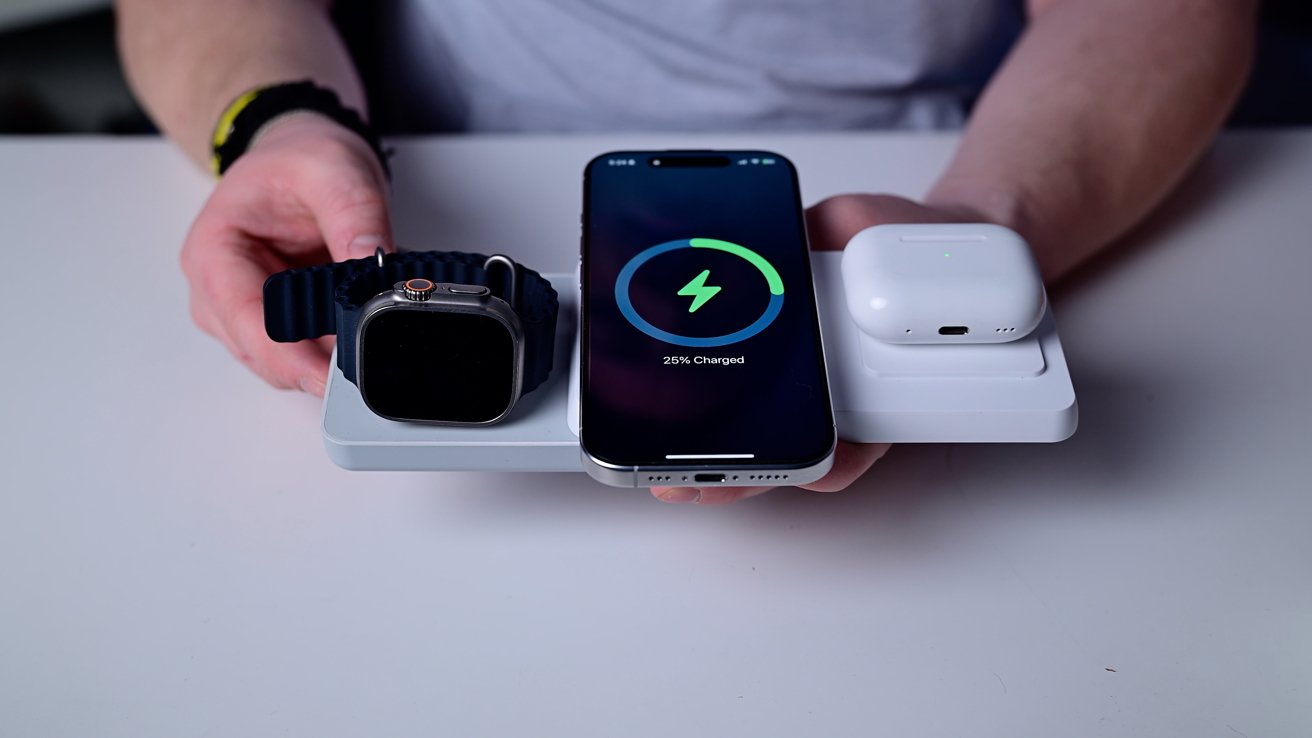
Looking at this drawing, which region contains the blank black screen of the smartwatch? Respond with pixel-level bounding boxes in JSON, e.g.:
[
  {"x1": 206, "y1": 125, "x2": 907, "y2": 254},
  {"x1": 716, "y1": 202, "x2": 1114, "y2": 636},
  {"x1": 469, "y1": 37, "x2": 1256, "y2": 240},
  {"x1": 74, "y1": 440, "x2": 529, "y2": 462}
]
[{"x1": 359, "y1": 310, "x2": 516, "y2": 423}]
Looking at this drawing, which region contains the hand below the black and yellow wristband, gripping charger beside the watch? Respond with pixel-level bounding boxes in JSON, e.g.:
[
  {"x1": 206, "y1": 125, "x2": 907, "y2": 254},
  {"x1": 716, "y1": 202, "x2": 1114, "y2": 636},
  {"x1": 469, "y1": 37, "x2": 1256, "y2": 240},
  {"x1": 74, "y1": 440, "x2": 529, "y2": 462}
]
[{"x1": 181, "y1": 113, "x2": 394, "y2": 397}]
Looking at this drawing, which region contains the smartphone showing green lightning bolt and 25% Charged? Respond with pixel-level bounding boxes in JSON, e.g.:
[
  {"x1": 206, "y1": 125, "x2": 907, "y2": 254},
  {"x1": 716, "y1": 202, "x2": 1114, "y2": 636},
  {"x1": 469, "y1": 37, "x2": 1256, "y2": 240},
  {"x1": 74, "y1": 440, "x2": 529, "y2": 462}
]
[{"x1": 580, "y1": 151, "x2": 836, "y2": 487}]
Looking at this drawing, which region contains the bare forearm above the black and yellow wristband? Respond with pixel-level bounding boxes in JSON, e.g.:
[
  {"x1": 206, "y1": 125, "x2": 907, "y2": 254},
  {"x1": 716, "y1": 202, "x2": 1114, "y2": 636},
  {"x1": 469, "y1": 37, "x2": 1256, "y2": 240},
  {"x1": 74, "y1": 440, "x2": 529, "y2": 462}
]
[{"x1": 117, "y1": 0, "x2": 365, "y2": 165}]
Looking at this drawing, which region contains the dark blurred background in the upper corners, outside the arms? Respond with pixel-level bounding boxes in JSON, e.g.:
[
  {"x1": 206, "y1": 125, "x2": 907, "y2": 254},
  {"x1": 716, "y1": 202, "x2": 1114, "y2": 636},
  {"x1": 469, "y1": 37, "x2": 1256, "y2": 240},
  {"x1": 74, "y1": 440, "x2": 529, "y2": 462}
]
[{"x1": 0, "y1": 0, "x2": 1312, "y2": 134}]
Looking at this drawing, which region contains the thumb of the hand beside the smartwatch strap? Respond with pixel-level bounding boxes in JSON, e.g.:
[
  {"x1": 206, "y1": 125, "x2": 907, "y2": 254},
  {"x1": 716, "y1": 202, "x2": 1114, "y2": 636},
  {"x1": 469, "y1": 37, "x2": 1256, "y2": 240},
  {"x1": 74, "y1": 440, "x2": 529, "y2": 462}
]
[{"x1": 307, "y1": 163, "x2": 396, "y2": 261}]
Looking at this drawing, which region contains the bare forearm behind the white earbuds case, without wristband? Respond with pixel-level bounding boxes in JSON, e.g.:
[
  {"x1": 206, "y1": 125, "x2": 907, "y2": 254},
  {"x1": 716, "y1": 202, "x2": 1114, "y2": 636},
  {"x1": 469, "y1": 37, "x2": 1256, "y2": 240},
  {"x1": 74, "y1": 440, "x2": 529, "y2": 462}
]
[{"x1": 926, "y1": 0, "x2": 1256, "y2": 280}]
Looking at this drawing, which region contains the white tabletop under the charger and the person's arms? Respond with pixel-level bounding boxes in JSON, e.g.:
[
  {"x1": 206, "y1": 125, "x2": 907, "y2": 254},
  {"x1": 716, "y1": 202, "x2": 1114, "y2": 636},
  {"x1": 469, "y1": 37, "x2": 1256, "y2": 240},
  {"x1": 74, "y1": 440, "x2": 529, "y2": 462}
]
[{"x1": 0, "y1": 131, "x2": 1312, "y2": 738}]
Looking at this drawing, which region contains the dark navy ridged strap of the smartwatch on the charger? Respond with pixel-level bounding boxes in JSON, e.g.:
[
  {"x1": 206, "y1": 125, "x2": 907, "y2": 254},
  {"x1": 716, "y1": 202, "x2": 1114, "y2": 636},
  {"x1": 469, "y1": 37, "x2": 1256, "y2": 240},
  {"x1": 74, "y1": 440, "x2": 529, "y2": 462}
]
[{"x1": 264, "y1": 251, "x2": 560, "y2": 393}]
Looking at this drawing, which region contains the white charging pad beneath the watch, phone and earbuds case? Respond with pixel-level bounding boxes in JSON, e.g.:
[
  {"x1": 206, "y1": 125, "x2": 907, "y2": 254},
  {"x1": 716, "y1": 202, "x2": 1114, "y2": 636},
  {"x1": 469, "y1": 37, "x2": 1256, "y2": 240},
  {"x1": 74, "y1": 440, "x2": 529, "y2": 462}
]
[{"x1": 323, "y1": 251, "x2": 1077, "y2": 471}]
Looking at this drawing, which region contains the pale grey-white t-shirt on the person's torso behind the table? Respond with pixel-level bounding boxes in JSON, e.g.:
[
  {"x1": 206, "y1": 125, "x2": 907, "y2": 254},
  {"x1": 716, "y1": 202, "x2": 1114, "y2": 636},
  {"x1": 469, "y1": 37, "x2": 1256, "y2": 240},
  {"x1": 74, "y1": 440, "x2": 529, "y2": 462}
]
[{"x1": 369, "y1": 0, "x2": 1022, "y2": 131}]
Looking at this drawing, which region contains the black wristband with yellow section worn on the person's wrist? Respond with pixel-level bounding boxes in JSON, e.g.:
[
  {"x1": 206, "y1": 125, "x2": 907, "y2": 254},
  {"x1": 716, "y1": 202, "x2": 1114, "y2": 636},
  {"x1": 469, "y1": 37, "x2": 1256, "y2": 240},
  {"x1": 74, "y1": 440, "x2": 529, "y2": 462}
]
[{"x1": 210, "y1": 80, "x2": 392, "y2": 179}]
